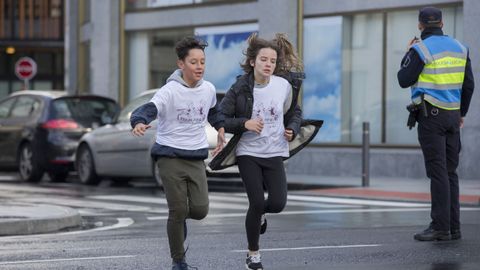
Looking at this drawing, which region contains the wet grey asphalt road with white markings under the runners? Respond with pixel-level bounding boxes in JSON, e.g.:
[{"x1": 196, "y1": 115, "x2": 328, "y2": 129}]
[{"x1": 0, "y1": 174, "x2": 480, "y2": 270}]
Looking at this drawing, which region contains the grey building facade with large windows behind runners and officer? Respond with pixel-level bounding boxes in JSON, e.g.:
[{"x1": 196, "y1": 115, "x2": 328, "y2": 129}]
[{"x1": 65, "y1": 0, "x2": 480, "y2": 179}]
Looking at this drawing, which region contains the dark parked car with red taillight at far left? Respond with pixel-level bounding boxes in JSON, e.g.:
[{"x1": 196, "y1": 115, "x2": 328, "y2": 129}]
[{"x1": 0, "y1": 90, "x2": 120, "y2": 182}]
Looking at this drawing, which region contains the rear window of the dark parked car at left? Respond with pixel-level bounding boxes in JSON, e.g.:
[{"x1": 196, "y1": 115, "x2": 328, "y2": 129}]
[{"x1": 50, "y1": 97, "x2": 118, "y2": 128}]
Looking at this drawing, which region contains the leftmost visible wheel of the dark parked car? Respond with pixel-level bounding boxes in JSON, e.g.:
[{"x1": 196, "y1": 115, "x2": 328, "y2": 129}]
[{"x1": 18, "y1": 143, "x2": 44, "y2": 182}]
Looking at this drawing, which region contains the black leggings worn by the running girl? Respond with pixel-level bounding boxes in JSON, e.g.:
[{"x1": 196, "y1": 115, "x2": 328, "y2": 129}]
[{"x1": 237, "y1": 156, "x2": 287, "y2": 251}]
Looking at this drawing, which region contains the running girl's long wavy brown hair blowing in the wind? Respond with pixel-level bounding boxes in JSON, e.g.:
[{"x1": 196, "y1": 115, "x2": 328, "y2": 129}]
[{"x1": 240, "y1": 33, "x2": 303, "y2": 74}]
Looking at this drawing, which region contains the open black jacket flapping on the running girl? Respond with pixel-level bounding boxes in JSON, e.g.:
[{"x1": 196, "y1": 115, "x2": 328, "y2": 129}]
[{"x1": 209, "y1": 72, "x2": 323, "y2": 170}]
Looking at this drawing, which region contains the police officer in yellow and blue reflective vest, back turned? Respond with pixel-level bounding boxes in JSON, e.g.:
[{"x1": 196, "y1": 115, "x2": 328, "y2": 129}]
[{"x1": 397, "y1": 7, "x2": 474, "y2": 241}]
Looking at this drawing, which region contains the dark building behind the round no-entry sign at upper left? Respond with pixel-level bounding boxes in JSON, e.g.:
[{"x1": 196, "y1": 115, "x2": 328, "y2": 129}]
[{"x1": 0, "y1": 0, "x2": 64, "y2": 98}]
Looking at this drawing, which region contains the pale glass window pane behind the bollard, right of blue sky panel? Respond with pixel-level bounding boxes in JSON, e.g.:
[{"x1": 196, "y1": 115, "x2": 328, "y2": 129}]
[{"x1": 342, "y1": 14, "x2": 383, "y2": 143}]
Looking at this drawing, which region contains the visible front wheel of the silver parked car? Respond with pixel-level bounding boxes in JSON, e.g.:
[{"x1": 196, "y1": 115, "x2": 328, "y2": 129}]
[{"x1": 76, "y1": 145, "x2": 102, "y2": 185}]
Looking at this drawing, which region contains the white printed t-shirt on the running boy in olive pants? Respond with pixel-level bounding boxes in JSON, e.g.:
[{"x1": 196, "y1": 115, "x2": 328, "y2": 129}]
[{"x1": 150, "y1": 81, "x2": 217, "y2": 150}]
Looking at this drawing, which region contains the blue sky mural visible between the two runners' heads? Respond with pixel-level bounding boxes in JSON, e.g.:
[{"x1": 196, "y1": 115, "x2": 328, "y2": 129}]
[{"x1": 195, "y1": 24, "x2": 258, "y2": 92}]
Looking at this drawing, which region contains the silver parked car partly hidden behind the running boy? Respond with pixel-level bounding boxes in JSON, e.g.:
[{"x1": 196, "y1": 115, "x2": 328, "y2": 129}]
[{"x1": 76, "y1": 90, "x2": 238, "y2": 186}]
